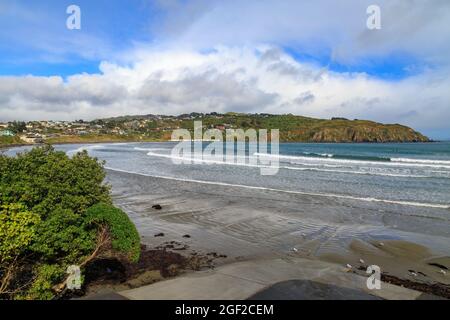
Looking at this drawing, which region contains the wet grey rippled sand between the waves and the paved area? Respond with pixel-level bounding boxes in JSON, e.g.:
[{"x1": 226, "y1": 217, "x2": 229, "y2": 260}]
[{"x1": 107, "y1": 170, "x2": 450, "y2": 292}]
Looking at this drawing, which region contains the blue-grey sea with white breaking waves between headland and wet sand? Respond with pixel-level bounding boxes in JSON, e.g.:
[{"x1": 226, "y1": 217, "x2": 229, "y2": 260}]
[{"x1": 8, "y1": 142, "x2": 450, "y2": 209}]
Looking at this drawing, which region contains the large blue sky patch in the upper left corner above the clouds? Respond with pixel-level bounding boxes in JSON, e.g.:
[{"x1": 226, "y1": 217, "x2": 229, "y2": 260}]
[{"x1": 0, "y1": 0, "x2": 157, "y2": 76}]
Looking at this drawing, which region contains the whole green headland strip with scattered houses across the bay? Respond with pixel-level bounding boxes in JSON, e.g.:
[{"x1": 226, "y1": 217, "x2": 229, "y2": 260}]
[{"x1": 4, "y1": 112, "x2": 429, "y2": 147}]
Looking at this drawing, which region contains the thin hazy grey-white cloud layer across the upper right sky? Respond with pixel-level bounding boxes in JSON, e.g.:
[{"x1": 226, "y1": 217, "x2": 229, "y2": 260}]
[{"x1": 149, "y1": 0, "x2": 450, "y2": 64}]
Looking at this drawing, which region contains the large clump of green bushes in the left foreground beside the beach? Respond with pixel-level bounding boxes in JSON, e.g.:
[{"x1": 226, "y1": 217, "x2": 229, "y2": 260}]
[{"x1": 0, "y1": 146, "x2": 140, "y2": 299}]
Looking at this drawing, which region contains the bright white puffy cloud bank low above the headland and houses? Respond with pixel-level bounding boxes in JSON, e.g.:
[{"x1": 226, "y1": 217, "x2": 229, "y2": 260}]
[{"x1": 0, "y1": 46, "x2": 450, "y2": 138}]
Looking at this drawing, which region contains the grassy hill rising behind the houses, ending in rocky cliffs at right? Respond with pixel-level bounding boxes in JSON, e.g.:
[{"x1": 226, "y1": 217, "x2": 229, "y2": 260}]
[{"x1": 96, "y1": 112, "x2": 429, "y2": 142}]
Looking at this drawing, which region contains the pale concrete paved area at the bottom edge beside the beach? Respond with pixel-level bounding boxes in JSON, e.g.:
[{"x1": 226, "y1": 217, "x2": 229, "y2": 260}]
[{"x1": 120, "y1": 258, "x2": 421, "y2": 300}]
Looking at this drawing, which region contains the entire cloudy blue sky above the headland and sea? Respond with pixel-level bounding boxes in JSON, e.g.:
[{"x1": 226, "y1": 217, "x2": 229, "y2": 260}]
[{"x1": 0, "y1": 0, "x2": 450, "y2": 139}]
